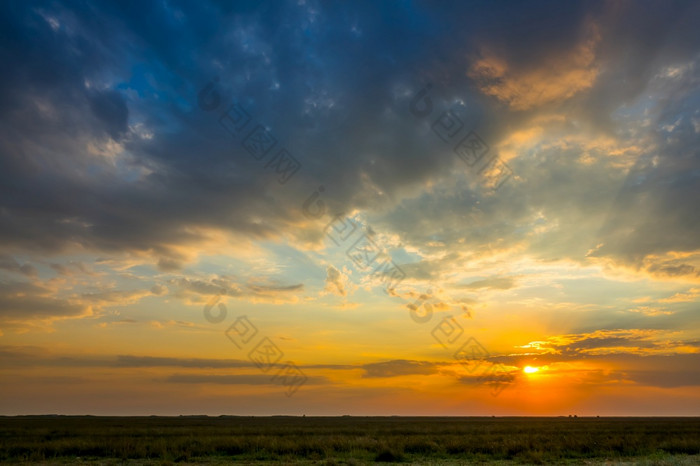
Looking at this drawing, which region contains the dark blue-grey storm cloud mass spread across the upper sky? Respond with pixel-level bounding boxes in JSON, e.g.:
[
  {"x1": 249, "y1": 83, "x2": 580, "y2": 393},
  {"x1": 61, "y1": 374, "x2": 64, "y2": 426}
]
[{"x1": 0, "y1": 1, "x2": 700, "y2": 276}]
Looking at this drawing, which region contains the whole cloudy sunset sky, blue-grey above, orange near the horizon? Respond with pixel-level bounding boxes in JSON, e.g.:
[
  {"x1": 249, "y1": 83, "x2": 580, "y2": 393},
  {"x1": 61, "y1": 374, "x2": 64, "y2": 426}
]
[{"x1": 0, "y1": 0, "x2": 700, "y2": 416}]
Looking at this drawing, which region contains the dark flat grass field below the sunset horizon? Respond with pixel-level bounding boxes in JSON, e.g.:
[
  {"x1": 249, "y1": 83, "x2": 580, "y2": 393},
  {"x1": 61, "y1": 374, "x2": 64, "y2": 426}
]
[{"x1": 0, "y1": 416, "x2": 700, "y2": 465}]
